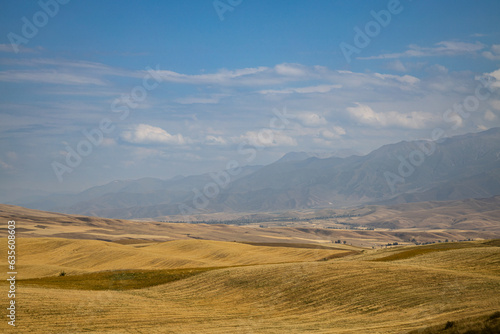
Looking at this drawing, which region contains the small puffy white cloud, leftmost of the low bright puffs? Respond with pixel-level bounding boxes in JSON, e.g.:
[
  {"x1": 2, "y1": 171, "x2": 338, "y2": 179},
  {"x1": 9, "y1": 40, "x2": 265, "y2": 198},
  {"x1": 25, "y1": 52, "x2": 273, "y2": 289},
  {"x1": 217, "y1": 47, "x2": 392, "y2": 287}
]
[{"x1": 121, "y1": 124, "x2": 190, "y2": 145}]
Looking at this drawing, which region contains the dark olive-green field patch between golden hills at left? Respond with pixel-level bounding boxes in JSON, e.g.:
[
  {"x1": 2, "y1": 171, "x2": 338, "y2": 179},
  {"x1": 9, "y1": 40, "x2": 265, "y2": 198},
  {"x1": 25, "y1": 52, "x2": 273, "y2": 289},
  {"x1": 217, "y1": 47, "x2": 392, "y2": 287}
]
[{"x1": 19, "y1": 267, "x2": 219, "y2": 291}]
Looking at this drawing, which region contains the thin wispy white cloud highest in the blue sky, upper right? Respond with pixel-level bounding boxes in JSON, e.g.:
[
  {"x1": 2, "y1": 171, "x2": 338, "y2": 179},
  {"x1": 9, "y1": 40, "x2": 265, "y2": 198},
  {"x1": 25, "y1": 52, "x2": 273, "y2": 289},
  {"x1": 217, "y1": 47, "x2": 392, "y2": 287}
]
[{"x1": 358, "y1": 41, "x2": 485, "y2": 59}]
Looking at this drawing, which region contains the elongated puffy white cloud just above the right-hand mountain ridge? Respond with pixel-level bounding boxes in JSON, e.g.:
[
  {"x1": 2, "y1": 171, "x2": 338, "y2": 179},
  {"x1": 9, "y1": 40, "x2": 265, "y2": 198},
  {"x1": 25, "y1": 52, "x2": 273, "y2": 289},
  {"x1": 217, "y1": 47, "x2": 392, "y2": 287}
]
[{"x1": 346, "y1": 103, "x2": 434, "y2": 129}]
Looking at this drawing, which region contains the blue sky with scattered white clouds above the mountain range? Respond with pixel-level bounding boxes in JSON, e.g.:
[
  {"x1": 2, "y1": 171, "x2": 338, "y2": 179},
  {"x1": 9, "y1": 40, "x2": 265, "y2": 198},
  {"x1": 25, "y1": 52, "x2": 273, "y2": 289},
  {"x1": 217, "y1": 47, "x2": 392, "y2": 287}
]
[{"x1": 0, "y1": 0, "x2": 500, "y2": 199}]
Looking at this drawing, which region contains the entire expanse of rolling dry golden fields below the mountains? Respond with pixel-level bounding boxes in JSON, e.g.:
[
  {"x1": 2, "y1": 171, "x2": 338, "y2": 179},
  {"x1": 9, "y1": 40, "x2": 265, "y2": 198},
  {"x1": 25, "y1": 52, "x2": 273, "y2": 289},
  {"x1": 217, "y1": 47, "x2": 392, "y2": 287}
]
[{"x1": 0, "y1": 205, "x2": 500, "y2": 334}]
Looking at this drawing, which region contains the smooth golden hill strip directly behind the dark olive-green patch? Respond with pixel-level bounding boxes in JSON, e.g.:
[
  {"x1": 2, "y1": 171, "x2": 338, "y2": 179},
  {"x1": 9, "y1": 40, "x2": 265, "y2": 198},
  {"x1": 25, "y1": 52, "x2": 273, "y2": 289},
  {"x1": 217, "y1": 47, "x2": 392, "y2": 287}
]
[{"x1": 0, "y1": 238, "x2": 349, "y2": 278}]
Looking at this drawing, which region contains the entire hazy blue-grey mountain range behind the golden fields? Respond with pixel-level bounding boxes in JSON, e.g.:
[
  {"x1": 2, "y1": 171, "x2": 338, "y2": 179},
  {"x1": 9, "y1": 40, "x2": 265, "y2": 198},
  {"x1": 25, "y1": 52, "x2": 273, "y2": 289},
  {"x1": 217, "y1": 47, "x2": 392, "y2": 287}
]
[{"x1": 10, "y1": 128, "x2": 500, "y2": 218}]
